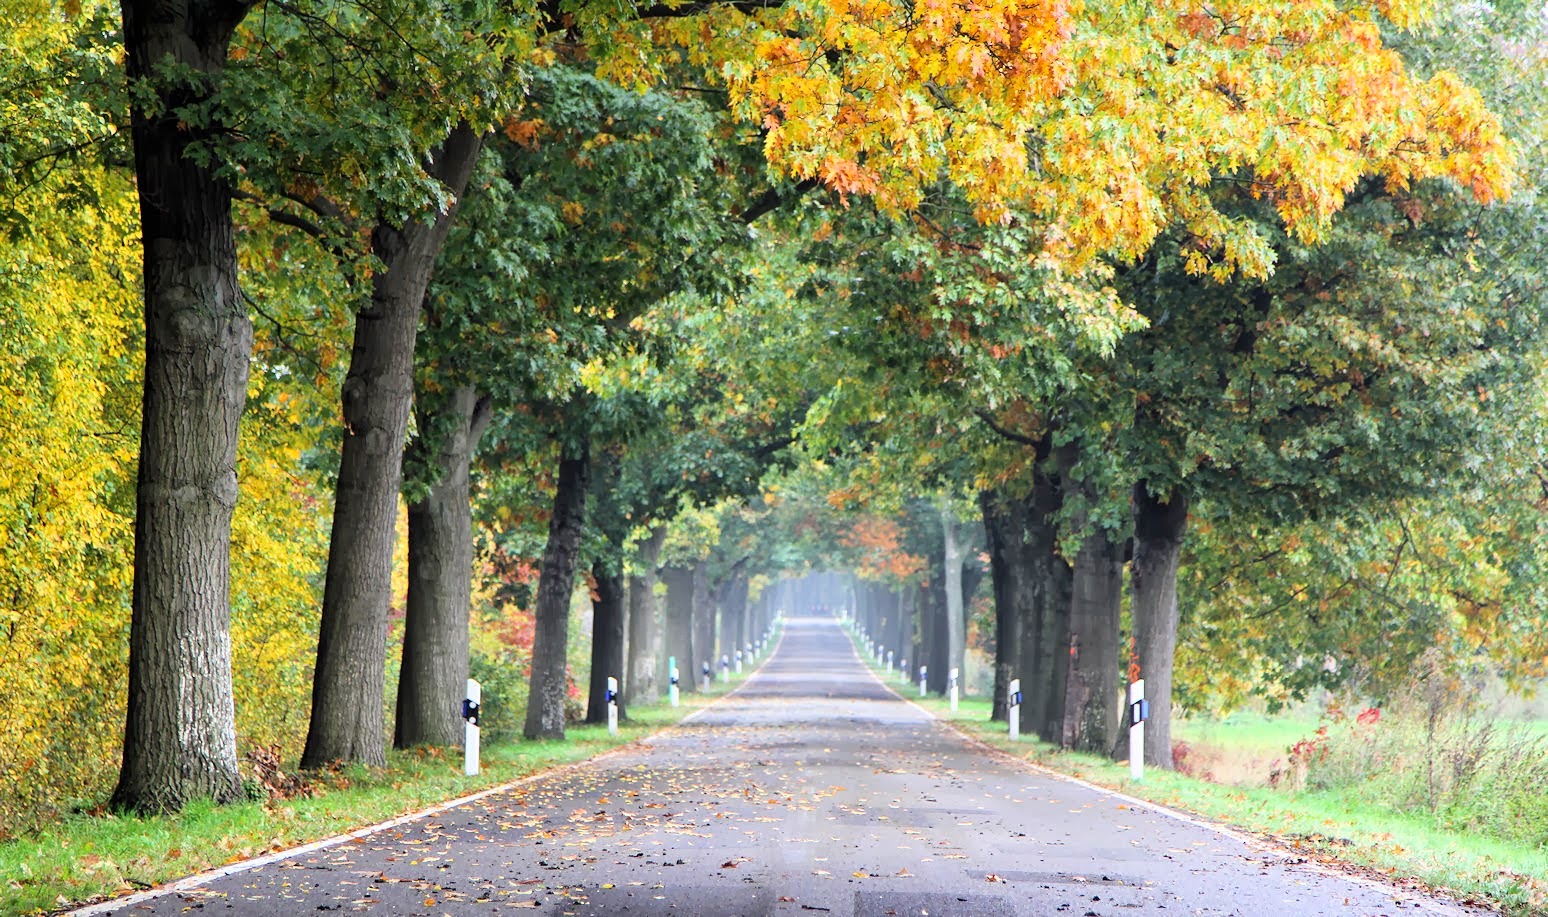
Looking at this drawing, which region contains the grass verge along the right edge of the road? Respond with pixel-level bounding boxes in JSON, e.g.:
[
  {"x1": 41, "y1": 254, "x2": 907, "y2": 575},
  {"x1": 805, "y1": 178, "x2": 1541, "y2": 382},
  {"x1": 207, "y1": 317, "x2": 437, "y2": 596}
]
[{"x1": 859, "y1": 625, "x2": 1548, "y2": 917}]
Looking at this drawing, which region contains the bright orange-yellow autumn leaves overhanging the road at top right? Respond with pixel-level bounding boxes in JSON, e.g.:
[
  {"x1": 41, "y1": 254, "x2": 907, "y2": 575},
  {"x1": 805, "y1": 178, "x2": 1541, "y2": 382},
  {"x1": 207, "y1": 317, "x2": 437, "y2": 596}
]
[{"x1": 640, "y1": 0, "x2": 1514, "y2": 276}]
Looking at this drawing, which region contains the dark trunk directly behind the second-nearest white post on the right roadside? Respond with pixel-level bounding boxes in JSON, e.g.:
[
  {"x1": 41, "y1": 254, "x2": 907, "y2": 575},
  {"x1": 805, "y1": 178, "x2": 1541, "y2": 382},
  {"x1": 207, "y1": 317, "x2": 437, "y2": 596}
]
[{"x1": 978, "y1": 491, "x2": 1033, "y2": 723}]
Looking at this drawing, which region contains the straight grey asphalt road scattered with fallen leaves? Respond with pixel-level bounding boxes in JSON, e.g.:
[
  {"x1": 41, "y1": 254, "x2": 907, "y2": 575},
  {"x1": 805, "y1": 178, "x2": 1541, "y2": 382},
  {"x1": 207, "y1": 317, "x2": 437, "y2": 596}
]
[{"x1": 78, "y1": 618, "x2": 1475, "y2": 917}]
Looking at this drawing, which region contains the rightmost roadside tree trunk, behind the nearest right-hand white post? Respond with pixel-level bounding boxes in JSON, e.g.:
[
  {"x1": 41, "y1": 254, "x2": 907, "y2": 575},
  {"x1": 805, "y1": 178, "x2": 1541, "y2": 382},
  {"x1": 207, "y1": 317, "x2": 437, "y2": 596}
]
[{"x1": 1130, "y1": 482, "x2": 1187, "y2": 768}]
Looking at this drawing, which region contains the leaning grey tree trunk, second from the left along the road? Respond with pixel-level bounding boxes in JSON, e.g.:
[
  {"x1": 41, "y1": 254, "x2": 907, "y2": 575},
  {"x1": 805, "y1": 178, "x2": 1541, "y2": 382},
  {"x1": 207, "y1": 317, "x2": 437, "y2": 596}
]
[{"x1": 302, "y1": 125, "x2": 483, "y2": 768}]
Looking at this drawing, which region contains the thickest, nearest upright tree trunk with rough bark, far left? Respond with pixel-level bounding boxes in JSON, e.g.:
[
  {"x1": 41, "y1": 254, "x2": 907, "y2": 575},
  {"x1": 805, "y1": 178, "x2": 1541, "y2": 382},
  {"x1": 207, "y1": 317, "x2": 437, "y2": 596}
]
[{"x1": 113, "y1": 0, "x2": 252, "y2": 813}]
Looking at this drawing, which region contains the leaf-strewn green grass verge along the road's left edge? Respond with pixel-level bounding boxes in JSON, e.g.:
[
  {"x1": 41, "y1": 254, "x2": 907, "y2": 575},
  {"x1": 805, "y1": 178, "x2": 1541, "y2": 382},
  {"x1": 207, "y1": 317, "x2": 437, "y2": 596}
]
[{"x1": 0, "y1": 638, "x2": 766, "y2": 914}]
